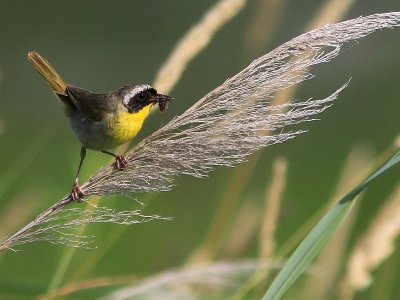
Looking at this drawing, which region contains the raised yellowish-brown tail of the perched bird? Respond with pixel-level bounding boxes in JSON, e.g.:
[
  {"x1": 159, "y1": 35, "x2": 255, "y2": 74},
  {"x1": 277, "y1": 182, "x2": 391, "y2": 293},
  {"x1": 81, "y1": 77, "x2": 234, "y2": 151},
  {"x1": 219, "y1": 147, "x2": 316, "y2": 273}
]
[{"x1": 28, "y1": 51, "x2": 67, "y2": 95}]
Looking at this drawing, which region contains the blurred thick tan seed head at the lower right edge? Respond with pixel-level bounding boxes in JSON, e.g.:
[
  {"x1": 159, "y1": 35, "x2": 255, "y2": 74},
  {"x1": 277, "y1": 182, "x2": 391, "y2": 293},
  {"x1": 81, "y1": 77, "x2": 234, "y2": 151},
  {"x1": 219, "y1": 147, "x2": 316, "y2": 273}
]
[{"x1": 342, "y1": 185, "x2": 400, "y2": 299}]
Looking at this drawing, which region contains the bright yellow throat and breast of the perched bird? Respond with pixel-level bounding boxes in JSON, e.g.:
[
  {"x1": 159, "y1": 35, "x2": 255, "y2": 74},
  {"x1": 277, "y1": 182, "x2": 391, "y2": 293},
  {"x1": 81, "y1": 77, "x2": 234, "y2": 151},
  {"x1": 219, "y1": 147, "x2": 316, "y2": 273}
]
[{"x1": 111, "y1": 105, "x2": 152, "y2": 144}]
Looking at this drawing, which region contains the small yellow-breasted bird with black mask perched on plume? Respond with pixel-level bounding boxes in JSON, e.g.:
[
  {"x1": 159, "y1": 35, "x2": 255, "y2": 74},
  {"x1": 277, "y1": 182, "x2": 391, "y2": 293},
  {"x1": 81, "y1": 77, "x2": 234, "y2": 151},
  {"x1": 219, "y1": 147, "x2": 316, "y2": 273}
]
[{"x1": 28, "y1": 52, "x2": 173, "y2": 201}]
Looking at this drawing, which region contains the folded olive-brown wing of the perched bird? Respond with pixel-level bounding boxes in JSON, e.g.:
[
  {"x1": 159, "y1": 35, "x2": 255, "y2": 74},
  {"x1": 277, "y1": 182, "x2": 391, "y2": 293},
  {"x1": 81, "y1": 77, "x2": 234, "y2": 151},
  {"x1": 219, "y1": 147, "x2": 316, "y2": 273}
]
[{"x1": 65, "y1": 85, "x2": 116, "y2": 121}]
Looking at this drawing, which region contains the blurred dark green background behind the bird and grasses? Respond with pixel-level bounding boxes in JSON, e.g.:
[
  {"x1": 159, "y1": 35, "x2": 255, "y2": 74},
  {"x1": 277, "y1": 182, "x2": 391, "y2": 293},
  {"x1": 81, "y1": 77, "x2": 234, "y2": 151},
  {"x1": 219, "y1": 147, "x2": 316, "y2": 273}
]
[{"x1": 0, "y1": 0, "x2": 400, "y2": 299}]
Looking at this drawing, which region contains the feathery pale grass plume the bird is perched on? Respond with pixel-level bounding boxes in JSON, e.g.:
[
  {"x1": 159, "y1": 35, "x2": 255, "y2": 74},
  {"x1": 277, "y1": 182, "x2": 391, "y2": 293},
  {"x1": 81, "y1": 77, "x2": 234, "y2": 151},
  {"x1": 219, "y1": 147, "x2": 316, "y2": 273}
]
[{"x1": 0, "y1": 12, "x2": 400, "y2": 250}]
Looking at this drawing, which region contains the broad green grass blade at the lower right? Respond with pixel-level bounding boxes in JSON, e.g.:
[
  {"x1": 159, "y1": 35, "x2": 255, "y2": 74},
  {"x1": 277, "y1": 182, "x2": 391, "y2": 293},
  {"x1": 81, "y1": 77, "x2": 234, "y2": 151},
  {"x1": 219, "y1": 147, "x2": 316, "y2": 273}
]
[{"x1": 263, "y1": 151, "x2": 400, "y2": 300}]
